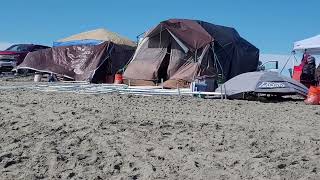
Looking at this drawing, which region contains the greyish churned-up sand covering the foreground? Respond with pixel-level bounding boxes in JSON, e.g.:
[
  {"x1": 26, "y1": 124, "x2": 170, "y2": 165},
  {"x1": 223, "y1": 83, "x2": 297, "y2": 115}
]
[{"x1": 0, "y1": 82, "x2": 320, "y2": 179}]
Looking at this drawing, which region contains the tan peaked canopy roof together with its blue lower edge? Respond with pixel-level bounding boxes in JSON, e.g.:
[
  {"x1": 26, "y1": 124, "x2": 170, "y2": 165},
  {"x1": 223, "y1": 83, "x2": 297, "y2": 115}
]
[{"x1": 53, "y1": 29, "x2": 136, "y2": 47}]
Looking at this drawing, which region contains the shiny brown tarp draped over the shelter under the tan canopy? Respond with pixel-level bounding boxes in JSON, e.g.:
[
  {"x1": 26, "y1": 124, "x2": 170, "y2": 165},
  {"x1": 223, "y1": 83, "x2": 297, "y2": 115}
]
[{"x1": 17, "y1": 42, "x2": 134, "y2": 82}]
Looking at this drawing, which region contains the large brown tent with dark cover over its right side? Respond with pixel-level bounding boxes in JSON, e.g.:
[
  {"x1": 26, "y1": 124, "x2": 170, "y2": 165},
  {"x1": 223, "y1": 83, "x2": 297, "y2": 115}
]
[{"x1": 124, "y1": 19, "x2": 259, "y2": 88}]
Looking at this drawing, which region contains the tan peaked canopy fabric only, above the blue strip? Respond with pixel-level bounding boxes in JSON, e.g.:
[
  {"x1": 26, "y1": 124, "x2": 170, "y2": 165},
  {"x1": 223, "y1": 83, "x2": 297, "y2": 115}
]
[{"x1": 57, "y1": 29, "x2": 136, "y2": 47}]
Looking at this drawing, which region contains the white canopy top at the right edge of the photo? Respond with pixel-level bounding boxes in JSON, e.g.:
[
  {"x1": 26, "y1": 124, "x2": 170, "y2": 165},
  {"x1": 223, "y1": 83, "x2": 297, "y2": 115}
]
[{"x1": 293, "y1": 35, "x2": 320, "y2": 55}]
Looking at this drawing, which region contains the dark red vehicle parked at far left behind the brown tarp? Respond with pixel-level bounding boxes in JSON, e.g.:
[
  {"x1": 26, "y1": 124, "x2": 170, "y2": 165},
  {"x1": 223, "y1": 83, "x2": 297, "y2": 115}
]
[{"x1": 0, "y1": 44, "x2": 50, "y2": 73}]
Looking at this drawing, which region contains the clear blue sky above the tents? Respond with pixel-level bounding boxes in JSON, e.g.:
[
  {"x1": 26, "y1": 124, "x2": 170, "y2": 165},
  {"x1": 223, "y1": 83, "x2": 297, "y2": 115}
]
[{"x1": 0, "y1": 0, "x2": 320, "y2": 54}]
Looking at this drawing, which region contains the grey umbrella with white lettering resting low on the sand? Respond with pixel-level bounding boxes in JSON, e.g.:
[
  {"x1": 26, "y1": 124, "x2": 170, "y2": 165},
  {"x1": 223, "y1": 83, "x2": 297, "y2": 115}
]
[{"x1": 216, "y1": 71, "x2": 308, "y2": 98}]
